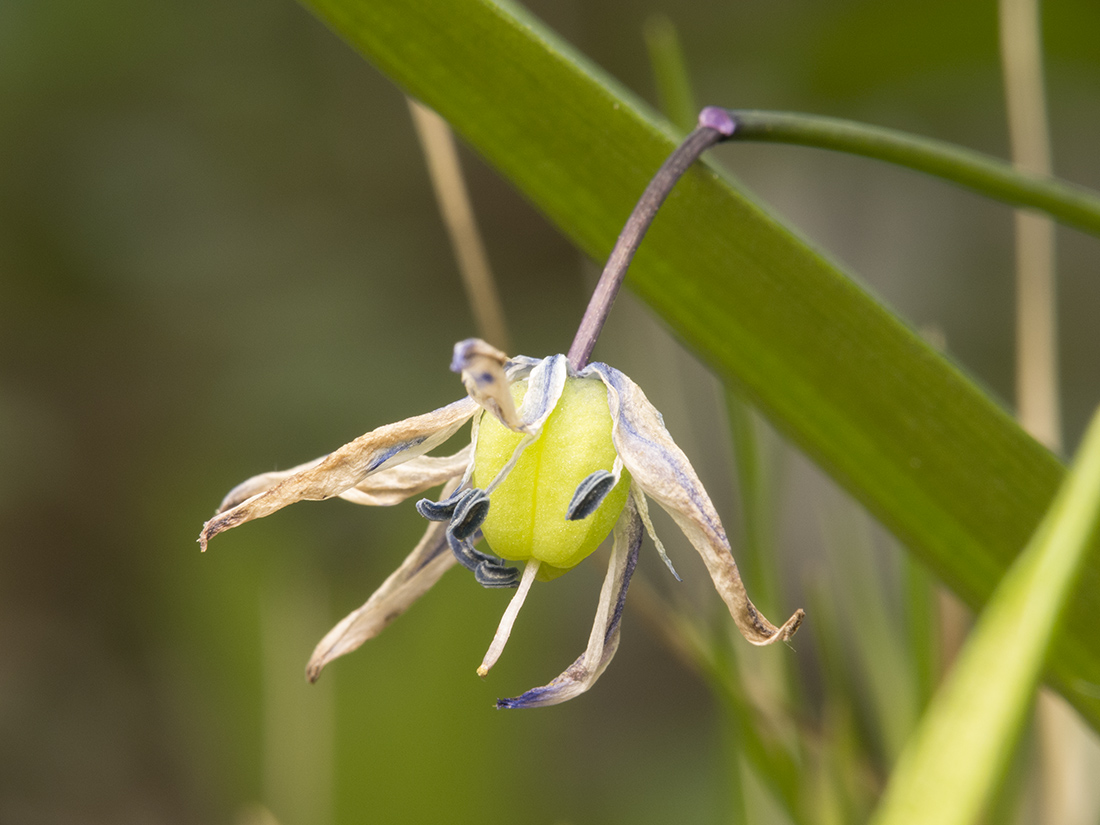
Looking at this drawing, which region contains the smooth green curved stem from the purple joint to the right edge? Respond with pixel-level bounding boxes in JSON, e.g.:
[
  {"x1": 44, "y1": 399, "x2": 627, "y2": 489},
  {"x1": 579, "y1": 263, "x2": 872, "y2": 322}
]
[{"x1": 726, "y1": 109, "x2": 1100, "y2": 235}]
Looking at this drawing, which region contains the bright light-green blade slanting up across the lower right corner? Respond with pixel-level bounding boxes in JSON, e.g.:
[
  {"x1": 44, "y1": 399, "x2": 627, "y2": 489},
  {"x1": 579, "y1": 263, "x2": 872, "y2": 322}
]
[{"x1": 872, "y1": 413, "x2": 1100, "y2": 825}]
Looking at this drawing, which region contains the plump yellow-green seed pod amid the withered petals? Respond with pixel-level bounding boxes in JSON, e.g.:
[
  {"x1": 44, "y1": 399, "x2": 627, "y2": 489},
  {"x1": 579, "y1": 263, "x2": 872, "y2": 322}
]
[{"x1": 474, "y1": 378, "x2": 630, "y2": 579}]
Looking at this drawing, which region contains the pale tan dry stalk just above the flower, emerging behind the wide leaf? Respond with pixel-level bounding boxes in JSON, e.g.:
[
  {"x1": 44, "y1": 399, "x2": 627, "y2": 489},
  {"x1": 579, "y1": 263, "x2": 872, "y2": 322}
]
[{"x1": 408, "y1": 98, "x2": 512, "y2": 352}]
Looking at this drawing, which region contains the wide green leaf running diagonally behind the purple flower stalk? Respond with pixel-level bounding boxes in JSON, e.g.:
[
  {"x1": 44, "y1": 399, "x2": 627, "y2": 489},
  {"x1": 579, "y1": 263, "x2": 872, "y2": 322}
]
[{"x1": 304, "y1": 0, "x2": 1100, "y2": 725}]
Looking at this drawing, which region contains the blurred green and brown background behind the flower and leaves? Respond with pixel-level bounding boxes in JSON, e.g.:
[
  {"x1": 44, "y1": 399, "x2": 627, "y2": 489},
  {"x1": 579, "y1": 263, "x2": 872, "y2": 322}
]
[{"x1": 0, "y1": 0, "x2": 1100, "y2": 825}]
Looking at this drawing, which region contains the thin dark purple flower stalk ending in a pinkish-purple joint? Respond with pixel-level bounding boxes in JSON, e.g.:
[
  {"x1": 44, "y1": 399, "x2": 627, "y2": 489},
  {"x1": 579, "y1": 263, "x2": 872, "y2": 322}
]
[{"x1": 568, "y1": 106, "x2": 734, "y2": 370}]
